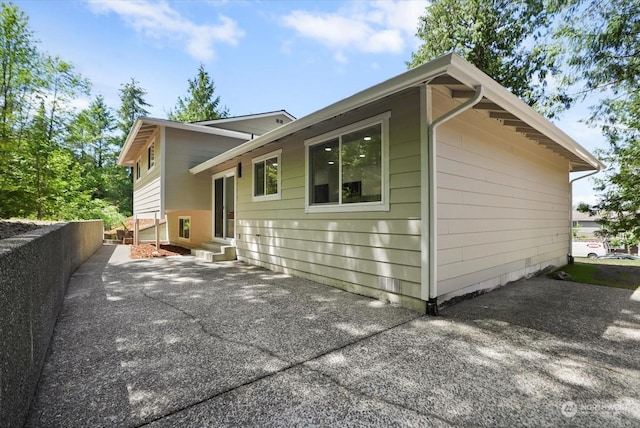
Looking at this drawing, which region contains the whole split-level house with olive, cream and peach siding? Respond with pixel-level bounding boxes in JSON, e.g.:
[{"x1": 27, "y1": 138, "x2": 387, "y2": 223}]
[{"x1": 120, "y1": 54, "x2": 603, "y2": 313}]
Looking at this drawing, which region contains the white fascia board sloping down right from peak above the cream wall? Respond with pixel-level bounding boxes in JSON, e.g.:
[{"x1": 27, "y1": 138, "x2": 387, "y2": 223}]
[{"x1": 448, "y1": 55, "x2": 605, "y2": 170}]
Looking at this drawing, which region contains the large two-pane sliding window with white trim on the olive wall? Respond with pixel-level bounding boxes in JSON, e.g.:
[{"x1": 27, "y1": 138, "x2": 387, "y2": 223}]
[{"x1": 305, "y1": 112, "x2": 390, "y2": 212}]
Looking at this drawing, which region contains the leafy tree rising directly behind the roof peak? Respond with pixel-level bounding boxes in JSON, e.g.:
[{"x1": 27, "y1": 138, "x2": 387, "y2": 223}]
[{"x1": 407, "y1": 0, "x2": 568, "y2": 114}]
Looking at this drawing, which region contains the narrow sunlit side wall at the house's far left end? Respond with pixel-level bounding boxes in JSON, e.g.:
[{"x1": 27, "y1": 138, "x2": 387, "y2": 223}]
[{"x1": 133, "y1": 127, "x2": 164, "y2": 214}]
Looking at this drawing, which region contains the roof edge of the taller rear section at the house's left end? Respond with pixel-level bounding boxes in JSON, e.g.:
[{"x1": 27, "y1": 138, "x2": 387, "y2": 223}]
[{"x1": 118, "y1": 117, "x2": 252, "y2": 166}]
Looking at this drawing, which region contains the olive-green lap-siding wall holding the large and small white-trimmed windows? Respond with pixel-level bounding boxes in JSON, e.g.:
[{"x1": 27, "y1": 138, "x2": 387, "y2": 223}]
[{"x1": 225, "y1": 89, "x2": 423, "y2": 310}]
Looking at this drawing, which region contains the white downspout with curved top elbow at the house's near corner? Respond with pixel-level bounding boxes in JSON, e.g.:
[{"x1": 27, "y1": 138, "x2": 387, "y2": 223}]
[{"x1": 422, "y1": 85, "x2": 484, "y2": 315}]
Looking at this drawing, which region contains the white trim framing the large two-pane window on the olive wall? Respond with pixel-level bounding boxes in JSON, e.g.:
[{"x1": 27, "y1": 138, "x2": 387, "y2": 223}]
[{"x1": 304, "y1": 111, "x2": 391, "y2": 213}]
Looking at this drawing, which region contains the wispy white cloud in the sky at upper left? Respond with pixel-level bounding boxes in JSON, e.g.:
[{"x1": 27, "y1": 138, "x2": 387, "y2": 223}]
[{"x1": 88, "y1": 0, "x2": 245, "y2": 61}]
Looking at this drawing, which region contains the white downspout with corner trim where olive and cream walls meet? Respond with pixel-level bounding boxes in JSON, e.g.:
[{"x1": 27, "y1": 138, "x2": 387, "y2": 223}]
[{"x1": 421, "y1": 84, "x2": 484, "y2": 315}]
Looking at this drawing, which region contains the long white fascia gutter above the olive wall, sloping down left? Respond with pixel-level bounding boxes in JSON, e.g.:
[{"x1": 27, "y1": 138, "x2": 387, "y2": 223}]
[{"x1": 189, "y1": 54, "x2": 452, "y2": 174}]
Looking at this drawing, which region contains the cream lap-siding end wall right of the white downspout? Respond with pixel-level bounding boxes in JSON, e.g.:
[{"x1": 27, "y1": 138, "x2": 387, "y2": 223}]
[{"x1": 434, "y1": 91, "x2": 570, "y2": 301}]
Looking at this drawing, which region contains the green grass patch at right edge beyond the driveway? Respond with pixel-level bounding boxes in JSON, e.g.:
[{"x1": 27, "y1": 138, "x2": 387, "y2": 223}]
[{"x1": 560, "y1": 259, "x2": 640, "y2": 290}]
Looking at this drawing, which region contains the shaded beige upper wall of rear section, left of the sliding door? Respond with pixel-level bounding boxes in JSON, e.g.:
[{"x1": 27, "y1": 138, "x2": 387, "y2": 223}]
[{"x1": 165, "y1": 128, "x2": 245, "y2": 213}]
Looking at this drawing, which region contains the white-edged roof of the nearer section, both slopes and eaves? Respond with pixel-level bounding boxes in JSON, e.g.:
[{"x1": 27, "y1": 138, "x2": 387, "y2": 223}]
[{"x1": 189, "y1": 53, "x2": 604, "y2": 174}]
